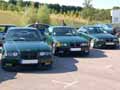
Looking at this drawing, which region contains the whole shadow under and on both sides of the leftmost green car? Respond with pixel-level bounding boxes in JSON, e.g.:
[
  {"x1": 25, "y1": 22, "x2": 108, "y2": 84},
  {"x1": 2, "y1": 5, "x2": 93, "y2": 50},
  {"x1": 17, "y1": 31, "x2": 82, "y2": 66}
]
[{"x1": 0, "y1": 57, "x2": 78, "y2": 76}]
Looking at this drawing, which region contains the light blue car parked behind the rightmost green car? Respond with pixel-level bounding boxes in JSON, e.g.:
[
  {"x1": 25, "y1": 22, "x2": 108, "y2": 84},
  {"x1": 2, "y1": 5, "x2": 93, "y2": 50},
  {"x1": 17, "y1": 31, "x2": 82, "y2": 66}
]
[{"x1": 95, "y1": 24, "x2": 113, "y2": 34}]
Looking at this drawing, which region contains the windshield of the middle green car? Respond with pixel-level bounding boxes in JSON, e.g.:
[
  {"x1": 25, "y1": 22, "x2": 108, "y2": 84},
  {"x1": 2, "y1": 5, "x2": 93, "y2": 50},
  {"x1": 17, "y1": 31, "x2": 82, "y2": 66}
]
[{"x1": 53, "y1": 27, "x2": 76, "y2": 36}]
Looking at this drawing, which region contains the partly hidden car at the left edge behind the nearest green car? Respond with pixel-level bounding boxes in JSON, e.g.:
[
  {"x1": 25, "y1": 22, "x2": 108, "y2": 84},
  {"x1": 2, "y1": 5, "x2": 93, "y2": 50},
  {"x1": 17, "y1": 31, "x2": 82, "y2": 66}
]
[{"x1": 0, "y1": 24, "x2": 16, "y2": 46}]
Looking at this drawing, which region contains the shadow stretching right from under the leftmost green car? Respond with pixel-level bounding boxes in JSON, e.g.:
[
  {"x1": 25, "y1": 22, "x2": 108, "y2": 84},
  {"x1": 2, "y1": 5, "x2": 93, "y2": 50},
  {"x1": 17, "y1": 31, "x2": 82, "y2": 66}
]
[{"x1": 20, "y1": 56, "x2": 78, "y2": 74}]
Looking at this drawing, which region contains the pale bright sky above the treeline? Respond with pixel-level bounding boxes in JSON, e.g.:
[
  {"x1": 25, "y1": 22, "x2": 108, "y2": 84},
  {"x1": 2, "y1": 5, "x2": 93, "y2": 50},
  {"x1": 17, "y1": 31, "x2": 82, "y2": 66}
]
[{"x1": 8, "y1": 0, "x2": 120, "y2": 9}]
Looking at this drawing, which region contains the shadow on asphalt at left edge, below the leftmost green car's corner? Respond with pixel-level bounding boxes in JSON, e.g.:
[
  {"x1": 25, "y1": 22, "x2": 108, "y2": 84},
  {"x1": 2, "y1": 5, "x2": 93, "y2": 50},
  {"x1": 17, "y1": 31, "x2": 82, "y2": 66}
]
[{"x1": 0, "y1": 64, "x2": 17, "y2": 84}]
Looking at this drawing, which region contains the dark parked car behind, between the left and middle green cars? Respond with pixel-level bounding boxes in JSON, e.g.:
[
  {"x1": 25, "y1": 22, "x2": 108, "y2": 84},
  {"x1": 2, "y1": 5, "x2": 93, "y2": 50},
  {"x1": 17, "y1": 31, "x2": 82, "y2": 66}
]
[{"x1": 27, "y1": 23, "x2": 49, "y2": 36}]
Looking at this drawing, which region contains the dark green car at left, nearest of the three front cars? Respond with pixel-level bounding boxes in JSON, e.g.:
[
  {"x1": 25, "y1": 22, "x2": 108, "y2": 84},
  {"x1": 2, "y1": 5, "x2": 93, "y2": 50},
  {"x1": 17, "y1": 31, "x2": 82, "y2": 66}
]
[{"x1": 1, "y1": 27, "x2": 53, "y2": 70}]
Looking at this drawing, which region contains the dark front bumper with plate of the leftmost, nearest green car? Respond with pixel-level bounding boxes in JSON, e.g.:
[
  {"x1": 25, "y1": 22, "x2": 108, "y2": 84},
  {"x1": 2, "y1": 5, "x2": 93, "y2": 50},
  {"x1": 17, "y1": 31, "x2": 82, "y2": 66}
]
[{"x1": 1, "y1": 56, "x2": 53, "y2": 67}]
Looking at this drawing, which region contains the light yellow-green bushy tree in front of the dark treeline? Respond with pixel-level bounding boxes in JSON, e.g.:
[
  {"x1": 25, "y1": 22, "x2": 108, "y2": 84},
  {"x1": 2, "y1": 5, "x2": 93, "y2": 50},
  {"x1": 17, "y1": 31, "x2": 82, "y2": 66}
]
[{"x1": 37, "y1": 5, "x2": 50, "y2": 24}]
